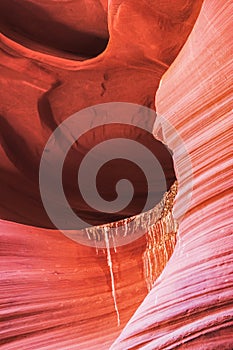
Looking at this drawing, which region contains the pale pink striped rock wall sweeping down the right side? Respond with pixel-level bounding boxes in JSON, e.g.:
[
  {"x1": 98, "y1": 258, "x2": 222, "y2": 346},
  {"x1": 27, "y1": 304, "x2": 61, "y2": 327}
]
[{"x1": 111, "y1": 0, "x2": 233, "y2": 350}]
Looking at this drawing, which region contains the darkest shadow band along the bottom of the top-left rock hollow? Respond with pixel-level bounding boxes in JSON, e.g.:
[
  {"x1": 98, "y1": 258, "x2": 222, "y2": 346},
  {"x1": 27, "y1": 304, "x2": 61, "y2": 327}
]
[{"x1": 0, "y1": 0, "x2": 108, "y2": 59}]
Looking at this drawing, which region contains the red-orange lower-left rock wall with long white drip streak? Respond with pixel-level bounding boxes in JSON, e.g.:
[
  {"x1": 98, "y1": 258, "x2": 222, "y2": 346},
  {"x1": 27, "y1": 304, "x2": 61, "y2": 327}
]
[{"x1": 0, "y1": 185, "x2": 176, "y2": 350}]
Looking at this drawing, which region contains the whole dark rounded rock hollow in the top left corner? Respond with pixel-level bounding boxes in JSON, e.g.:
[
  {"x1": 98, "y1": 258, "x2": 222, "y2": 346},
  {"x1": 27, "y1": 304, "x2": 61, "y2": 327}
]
[{"x1": 0, "y1": 0, "x2": 109, "y2": 60}]
